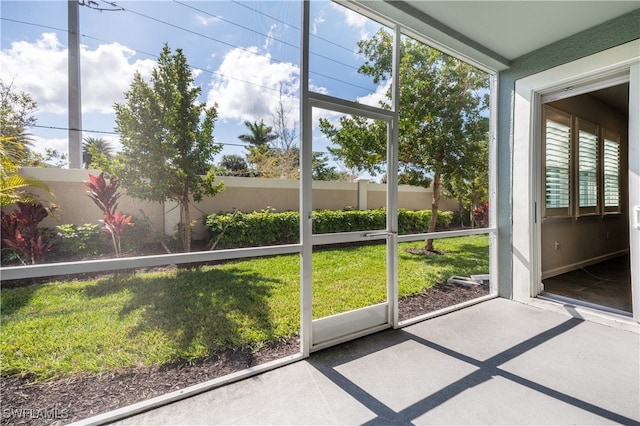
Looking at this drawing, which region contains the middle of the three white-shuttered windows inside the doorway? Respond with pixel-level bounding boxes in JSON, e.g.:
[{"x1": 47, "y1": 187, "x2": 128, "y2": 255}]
[{"x1": 576, "y1": 119, "x2": 598, "y2": 214}]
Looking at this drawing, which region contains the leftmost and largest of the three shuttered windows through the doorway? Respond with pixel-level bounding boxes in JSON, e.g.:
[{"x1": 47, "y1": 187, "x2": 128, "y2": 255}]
[{"x1": 543, "y1": 107, "x2": 571, "y2": 216}]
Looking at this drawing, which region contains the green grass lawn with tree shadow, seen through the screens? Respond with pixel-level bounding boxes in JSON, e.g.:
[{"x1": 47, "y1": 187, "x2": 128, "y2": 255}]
[{"x1": 0, "y1": 235, "x2": 489, "y2": 380}]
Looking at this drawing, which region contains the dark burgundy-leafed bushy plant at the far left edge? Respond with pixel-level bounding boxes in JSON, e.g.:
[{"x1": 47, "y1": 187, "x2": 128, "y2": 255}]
[{"x1": 2, "y1": 201, "x2": 54, "y2": 264}]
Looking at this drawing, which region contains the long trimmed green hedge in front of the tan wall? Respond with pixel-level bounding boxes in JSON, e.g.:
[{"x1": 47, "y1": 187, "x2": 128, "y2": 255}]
[{"x1": 204, "y1": 209, "x2": 453, "y2": 249}]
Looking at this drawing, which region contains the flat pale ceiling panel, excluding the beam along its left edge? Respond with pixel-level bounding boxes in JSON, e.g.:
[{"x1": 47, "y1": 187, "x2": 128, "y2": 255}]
[{"x1": 407, "y1": 0, "x2": 640, "y2": 60}]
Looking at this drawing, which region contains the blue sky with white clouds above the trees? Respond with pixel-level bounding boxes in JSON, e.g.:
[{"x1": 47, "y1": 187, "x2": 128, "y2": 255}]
[{"x1": 0, "y1": 0, "x2": 386, "y2": 171}]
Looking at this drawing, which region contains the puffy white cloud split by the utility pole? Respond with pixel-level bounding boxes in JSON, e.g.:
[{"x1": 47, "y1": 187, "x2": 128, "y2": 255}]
[{"x1": 0, "y1": 33, "x2": 155, "y2": 114}]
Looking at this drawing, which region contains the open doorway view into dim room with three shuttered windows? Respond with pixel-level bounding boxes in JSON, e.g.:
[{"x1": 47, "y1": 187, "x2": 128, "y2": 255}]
[{"x1": 540, "y1": 82, "x2": 632, "y2": 315}]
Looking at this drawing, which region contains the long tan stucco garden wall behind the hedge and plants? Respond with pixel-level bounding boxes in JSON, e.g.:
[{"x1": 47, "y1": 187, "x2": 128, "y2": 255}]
[{"x1": 10, "y1": 168, "x2": 458, "y2": 239}]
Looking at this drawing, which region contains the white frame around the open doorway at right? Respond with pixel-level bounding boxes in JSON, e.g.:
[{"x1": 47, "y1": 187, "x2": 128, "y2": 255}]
[{"x1": 512, "y1": 40, "x2": 640, "y2": 322}]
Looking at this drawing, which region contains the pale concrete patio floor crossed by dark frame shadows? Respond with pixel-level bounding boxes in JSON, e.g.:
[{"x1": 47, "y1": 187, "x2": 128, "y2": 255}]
[{"x1": 112, "y1": 299, "x2": 640, "y2": 425}]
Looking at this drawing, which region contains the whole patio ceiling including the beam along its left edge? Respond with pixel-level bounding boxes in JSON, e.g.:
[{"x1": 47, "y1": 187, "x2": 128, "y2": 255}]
[{"x1": 359, "y1": 0, "x2": 640, "y2": 70}]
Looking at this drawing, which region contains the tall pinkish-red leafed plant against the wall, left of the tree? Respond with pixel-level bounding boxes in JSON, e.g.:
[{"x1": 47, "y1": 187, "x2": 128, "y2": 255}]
[{"x1": 85, "y1": 173, "x2": 133, "y2": 257}]
